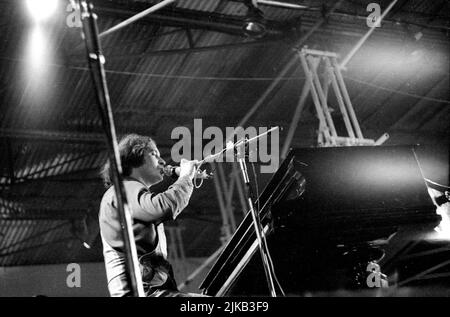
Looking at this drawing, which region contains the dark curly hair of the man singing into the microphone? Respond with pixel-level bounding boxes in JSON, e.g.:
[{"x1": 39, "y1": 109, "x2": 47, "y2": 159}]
[{"x1": 100, "y1": 134, "x2": 157, "y2": 188}]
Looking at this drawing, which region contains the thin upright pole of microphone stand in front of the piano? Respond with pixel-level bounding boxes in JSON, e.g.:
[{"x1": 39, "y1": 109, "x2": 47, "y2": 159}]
[{"x1": 235, "y1": 139, "x2": 277, "y2": 297}]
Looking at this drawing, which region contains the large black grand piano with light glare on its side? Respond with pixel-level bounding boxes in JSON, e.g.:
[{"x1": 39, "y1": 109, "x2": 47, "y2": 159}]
[{"x1": 200, "y1": 146, "x2": 441, "y2": 296}]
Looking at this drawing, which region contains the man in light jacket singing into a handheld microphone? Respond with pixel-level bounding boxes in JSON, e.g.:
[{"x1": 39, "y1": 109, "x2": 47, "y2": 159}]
[{"x1": 99, "y1": 134, "x2": 205, "y2": 297}]
